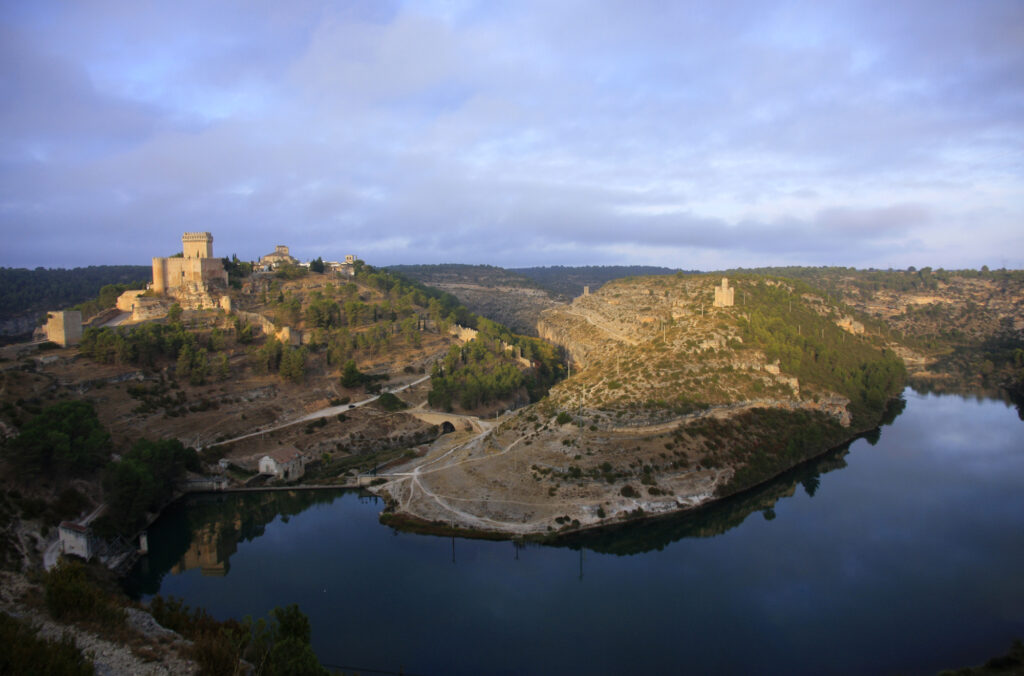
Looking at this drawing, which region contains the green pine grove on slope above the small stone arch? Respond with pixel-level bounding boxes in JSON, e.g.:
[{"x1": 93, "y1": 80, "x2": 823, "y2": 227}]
[{"x1": 427, "y1": 318, "x2": 565, "y2": 411}]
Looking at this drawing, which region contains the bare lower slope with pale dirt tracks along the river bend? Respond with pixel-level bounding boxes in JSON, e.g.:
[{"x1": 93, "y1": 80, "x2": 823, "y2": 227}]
[{"x1": 369, "y1": 391, "x2": 900, "y2": 540}]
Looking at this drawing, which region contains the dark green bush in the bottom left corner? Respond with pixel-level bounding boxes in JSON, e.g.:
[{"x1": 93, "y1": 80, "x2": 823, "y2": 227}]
[{"x1": 0, "y1": 612, "x2": 95, "y2": 676}]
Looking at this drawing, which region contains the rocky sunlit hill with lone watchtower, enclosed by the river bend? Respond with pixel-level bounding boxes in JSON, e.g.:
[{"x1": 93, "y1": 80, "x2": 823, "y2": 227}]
[{"x1": 379, "y1": 273, "x2": 904, "y2": 535}]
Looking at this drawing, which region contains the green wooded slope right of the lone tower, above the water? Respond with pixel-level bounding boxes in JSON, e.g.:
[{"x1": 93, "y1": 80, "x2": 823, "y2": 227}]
[{"x1": 739, "y1": 278, "x2": 906, "y2": 419}]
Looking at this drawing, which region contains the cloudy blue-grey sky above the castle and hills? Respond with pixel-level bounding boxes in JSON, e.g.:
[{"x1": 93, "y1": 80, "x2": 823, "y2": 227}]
[{"x1": 0, "y1": 0, "x2": 1024, "y2": 269}]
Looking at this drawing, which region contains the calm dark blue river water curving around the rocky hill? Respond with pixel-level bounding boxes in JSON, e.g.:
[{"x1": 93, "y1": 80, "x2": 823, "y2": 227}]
[{"x1": 129, "y1": 390, "x2": 1024, "y2": 674}]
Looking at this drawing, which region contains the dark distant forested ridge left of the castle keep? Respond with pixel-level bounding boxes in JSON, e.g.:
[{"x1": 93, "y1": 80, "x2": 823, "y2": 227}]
[{"x1": 0, "y1": 265, "x2": 153, "y2": 320}]
